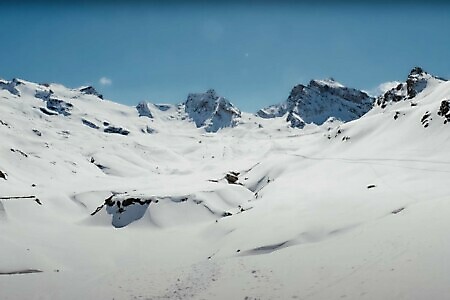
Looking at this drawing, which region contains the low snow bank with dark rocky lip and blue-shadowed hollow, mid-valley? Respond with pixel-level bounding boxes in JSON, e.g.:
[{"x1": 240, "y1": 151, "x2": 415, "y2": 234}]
[{"x1": 87, "y1": 185, "x2": 255, "y2": 228}]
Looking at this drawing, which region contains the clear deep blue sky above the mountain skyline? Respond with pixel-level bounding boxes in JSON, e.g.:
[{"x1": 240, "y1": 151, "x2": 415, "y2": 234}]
[{"x1": 0, "y1": 1, "x2": 450, "y2": 112}]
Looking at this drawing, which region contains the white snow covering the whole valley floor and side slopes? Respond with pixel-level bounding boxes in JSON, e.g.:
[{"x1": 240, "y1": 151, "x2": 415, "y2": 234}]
[{"x1": 0, "y1": 73, "x2": 450, "y2": 300}]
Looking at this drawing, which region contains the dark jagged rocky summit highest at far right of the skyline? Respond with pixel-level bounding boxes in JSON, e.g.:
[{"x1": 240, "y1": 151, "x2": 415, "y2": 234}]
[{"x1": 376, "y1": 67, "x2": 447, "y2": 108}]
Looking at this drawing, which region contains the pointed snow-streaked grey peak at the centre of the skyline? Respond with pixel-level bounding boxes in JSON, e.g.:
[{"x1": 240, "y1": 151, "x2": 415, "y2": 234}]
[{"x1": 184, "y1": 89, "x2": 241, "y2": 132}]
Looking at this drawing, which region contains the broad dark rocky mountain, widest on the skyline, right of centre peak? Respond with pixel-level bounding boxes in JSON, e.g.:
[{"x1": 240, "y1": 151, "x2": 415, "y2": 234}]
[{"x1": 257, "y1": 78, "x2": 375, "y2": 128}]
